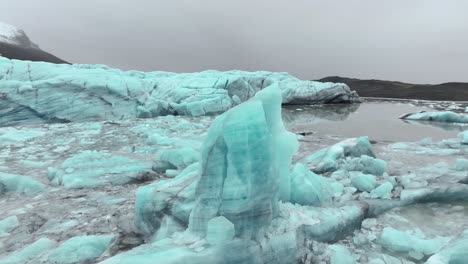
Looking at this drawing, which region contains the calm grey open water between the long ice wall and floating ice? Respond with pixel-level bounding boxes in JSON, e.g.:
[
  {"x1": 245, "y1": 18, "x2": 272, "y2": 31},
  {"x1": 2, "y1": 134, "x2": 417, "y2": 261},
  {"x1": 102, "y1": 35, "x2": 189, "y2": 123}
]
[{"x1": 283, "y1": 101, "x2": 468, "y2": 142}]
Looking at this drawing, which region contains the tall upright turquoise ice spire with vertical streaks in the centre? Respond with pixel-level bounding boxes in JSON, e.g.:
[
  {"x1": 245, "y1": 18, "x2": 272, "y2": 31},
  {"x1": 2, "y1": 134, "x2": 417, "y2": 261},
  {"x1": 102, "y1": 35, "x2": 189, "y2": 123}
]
[{"x1": 189, "y1": 86, "x2": 298, "y2": 239}]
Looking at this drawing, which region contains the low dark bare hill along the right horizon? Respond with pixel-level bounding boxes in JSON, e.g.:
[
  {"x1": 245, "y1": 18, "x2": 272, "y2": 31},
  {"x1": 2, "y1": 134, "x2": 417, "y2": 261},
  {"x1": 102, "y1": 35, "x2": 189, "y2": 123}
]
[{"x1": 317, "y1": 76, "x2": 468, "y2": 101}]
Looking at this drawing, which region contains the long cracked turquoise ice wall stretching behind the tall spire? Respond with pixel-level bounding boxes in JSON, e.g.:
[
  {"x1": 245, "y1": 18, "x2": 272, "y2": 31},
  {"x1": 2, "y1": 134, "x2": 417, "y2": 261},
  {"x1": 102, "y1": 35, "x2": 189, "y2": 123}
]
[{"x1": 0, "y1": 58, "x2": 359, "y2": 126}]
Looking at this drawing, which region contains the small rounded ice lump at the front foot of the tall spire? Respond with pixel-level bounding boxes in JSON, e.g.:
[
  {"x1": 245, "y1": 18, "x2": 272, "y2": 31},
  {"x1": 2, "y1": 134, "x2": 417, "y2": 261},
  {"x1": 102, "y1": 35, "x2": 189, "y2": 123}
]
[{"x1": 206, "y1": 216, "x2": 236, "y2": 245}]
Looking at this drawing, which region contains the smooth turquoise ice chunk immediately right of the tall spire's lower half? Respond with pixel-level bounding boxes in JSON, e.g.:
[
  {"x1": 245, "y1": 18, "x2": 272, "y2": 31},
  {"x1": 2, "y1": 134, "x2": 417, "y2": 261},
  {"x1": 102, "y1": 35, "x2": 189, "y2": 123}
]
[{"x1": 290, "y1": 163, "x2": 332, "y2": 206}]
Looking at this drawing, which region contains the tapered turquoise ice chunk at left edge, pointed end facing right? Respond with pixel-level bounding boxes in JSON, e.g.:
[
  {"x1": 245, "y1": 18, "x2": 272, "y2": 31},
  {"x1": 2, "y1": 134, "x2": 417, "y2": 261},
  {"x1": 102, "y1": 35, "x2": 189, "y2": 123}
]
[{"x1": 0, "y1": 172, "x2": 45, "y2": 195}]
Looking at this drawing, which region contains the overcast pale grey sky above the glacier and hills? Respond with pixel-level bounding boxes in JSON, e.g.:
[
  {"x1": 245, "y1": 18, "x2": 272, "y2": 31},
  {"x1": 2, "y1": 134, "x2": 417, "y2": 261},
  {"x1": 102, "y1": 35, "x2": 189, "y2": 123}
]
[{"x1": 0, "y1": 0, "x2": 468, "y2": 83}]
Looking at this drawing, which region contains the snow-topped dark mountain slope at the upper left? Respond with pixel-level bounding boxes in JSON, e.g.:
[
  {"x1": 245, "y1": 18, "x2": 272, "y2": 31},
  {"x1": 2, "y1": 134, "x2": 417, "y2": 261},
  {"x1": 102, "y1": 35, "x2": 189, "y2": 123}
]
[{"x1": 0, "y1": 22, "x2": 68, "y2": 63}]
